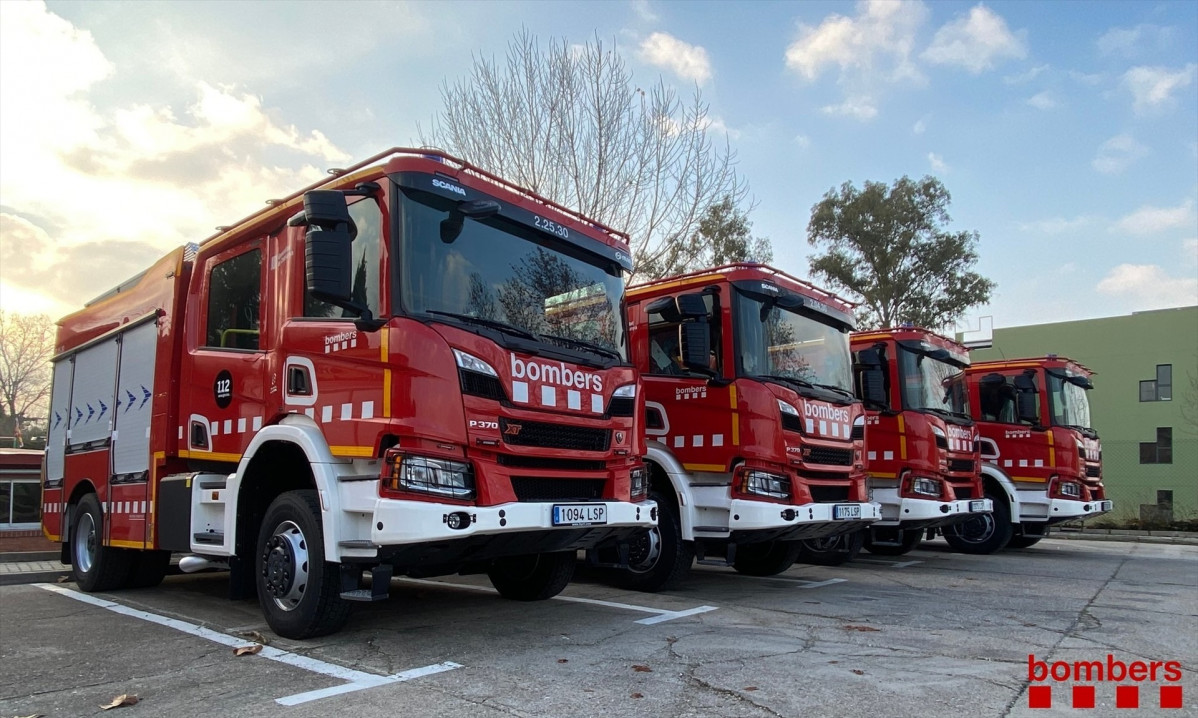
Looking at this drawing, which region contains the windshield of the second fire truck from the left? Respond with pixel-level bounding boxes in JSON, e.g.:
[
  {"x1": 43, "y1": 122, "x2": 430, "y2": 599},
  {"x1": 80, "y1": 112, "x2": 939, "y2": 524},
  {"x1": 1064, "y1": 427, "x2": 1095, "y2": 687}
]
[{"x1": 736, "y1": 294, "x2": 853, "y2": 392}]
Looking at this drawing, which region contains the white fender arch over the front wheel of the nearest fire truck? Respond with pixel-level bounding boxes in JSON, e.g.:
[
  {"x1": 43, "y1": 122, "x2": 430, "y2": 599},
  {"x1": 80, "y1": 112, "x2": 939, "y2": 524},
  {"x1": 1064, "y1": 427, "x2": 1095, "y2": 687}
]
[{"x1": 225, "y1": 414, "x2": 353, "y2": 561}]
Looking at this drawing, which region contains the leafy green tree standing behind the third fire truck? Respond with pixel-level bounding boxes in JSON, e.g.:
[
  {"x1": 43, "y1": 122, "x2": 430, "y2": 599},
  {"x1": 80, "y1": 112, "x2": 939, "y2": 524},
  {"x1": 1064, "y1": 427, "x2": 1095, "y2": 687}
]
[{"x1": 807, "y1": 176, "x2": 996, "y2": 330}]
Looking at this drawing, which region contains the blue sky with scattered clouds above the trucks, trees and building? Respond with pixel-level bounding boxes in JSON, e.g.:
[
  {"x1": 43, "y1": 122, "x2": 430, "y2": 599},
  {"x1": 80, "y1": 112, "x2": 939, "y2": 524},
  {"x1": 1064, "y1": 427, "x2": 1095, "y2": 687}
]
[{"x1": 0, "y1": 0, "x2": 1198, "y2": 328}]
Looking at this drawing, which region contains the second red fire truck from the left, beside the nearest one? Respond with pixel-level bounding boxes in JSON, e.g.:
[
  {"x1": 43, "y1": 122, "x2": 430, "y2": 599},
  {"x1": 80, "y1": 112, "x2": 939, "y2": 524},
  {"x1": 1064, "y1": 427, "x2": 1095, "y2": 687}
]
[{"x1": 599, "y1": 264, "x2": 879, "y2": 591}]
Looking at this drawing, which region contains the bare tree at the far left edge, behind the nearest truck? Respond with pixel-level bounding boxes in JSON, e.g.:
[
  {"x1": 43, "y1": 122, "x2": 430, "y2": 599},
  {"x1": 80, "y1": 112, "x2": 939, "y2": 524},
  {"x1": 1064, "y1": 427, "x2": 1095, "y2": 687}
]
[{"x1": 0, "y1": 312, "x2": 54, "y2": 445}]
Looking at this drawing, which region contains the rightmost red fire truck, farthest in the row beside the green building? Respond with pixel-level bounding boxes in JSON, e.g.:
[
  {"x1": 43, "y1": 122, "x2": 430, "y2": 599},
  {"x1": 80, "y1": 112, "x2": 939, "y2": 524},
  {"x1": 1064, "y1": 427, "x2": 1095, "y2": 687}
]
[{"x1": 945, "y1": 355, "x2": 1111, "y2": 554}]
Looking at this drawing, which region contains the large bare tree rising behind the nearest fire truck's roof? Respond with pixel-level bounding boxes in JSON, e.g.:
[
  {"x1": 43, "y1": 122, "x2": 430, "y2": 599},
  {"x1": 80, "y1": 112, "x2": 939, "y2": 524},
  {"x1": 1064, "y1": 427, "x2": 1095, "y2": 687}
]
[{"x1": 420, "y1": 30, "x2": 746, "y2": 280}]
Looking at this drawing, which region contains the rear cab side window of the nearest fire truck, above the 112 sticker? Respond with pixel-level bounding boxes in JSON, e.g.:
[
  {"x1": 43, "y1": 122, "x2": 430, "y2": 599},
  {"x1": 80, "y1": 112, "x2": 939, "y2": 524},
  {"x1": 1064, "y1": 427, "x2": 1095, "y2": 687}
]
[{"x1": 205, "y1": 249, "x2": 262, "y2": 349}]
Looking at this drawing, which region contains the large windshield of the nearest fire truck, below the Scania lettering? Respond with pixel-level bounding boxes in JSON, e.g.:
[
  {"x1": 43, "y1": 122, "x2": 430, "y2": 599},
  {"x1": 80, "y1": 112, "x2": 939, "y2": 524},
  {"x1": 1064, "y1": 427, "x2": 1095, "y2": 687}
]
[{"x1": 393, "y1": 189, "x2": 627, "y2": 362}]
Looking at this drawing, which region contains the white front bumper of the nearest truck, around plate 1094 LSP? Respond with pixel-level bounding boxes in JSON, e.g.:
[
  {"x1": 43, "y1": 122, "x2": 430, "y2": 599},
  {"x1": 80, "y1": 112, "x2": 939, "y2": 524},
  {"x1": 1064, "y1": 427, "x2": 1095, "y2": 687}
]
[{"x1": 370, "y1": 499, "x2": 658, "y2": 545}]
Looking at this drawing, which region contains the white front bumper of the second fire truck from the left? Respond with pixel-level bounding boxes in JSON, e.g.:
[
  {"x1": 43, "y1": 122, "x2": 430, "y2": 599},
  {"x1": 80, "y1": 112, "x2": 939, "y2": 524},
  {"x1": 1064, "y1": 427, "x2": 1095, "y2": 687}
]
[{"x1": 728, "y1": 499, "x2": 882, "y2": 543}]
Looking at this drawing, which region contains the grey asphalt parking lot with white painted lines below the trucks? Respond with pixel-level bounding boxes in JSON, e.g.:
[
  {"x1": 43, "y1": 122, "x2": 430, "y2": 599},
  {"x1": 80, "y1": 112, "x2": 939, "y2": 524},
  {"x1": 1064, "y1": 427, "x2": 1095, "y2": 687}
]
[{"x1": 0, "y1": 539, "x2": 1198, "y2": 717}]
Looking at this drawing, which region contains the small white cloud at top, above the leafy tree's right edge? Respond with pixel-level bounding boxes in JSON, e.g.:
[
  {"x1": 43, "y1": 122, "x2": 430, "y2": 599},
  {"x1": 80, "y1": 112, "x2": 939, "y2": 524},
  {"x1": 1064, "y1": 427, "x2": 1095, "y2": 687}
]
[{"x1": 920, "y1": 4, "x2": 1028, "y2": 74}]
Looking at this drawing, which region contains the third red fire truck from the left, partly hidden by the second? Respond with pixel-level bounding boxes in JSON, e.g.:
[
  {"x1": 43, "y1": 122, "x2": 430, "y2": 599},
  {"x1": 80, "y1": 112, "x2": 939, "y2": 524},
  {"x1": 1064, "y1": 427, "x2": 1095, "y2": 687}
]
[{"x1": 852, "y1": 327, "x2": 992, "y2": 555}]
